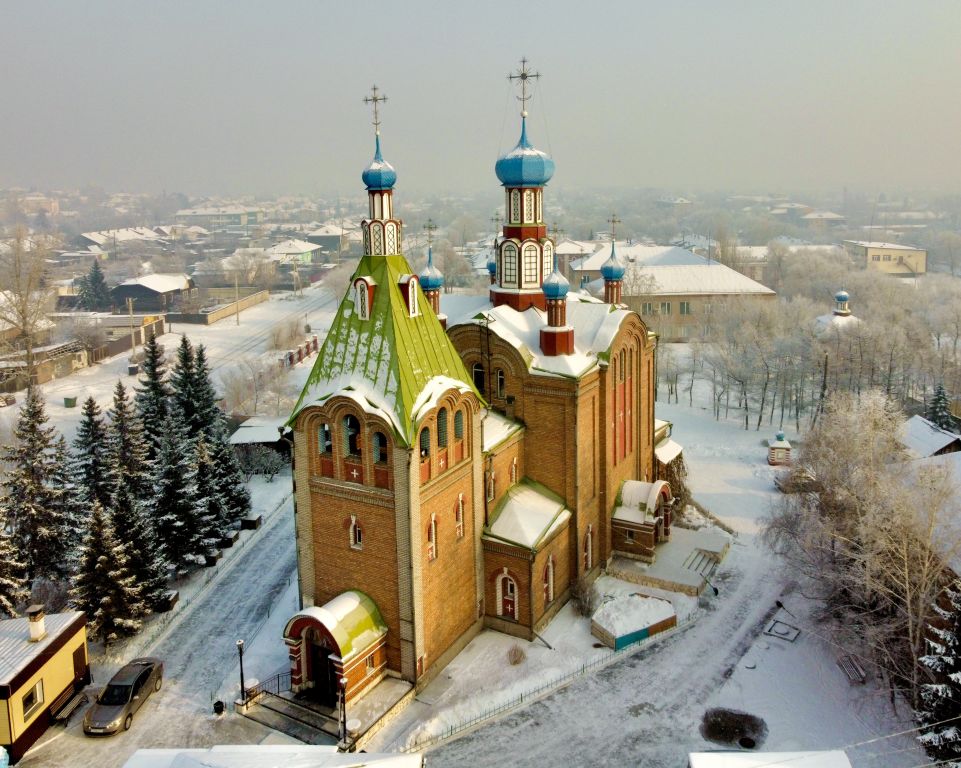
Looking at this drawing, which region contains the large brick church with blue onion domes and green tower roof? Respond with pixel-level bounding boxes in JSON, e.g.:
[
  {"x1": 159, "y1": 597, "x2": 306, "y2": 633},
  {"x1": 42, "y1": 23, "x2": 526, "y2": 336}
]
[{"x1": 284, "y1": 69, "x2": 673, "y2": 706}]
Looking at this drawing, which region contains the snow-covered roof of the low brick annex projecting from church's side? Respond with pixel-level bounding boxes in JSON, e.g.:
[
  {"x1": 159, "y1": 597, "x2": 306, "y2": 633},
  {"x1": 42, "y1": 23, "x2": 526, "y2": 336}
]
[{"x1": 484, "y1": 479, "x2": 571, "y2": 550}]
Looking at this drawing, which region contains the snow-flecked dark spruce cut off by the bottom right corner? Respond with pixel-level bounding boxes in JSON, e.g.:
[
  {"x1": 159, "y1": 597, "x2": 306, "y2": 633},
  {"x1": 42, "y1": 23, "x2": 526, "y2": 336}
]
[{"x1": 915, "y1": 581, "x2": 961, "y2": 761}]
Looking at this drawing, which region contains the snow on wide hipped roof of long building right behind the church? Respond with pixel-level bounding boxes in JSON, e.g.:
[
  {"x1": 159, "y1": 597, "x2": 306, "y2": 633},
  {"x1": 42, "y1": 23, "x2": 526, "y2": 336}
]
[{"x1": 590, "y1": 262, "x2": 775, "y2": 296}]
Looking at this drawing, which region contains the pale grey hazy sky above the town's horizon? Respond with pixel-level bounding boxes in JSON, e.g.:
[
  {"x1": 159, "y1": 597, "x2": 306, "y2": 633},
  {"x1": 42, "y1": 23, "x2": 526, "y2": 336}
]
[{"x1": 0, "y1": 0, "x2": 961, "y2": 195}]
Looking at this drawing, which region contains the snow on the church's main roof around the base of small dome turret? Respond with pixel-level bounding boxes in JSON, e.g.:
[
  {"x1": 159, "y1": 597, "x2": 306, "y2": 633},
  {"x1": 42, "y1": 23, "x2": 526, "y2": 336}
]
[{"x1": 441, "y1": 291, "x2": 630, "y2": 378}]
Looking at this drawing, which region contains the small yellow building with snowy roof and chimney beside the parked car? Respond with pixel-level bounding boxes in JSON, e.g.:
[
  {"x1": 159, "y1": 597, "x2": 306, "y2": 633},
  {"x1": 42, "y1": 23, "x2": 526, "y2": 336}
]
[{"x1": 0, "y1": 606, "x2": 90, "y2": 762}]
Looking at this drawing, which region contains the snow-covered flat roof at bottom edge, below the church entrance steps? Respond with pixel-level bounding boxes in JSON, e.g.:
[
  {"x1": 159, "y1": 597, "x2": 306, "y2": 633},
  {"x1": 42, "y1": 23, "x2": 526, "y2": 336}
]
[{"x1": 123, "y1": 744, "x2": 424, "y2": 768}]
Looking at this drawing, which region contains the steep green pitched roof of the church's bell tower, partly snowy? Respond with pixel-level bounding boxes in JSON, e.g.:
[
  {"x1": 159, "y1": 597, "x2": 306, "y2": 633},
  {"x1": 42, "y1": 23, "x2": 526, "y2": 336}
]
[{"x1": 291, "y1": 255, "x2": 480, "y2": 445}]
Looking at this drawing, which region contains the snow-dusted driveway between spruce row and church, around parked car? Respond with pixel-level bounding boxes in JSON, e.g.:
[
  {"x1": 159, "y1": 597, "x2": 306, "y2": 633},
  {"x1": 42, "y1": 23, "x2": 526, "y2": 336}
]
[{"x1": 20, "y1": 500, "x2": 296, "y2": 768}]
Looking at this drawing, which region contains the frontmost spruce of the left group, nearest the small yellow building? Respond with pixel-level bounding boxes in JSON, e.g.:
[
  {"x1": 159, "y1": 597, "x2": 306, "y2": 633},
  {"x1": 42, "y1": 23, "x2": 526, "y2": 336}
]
[{"x1": 71, "y1": 502, "x2": 145, "y2": 642}]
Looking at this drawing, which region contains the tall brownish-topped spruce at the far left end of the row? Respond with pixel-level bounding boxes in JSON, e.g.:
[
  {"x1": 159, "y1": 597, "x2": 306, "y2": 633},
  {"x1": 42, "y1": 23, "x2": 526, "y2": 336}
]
[{"x1": 2, "y1": 386, "x2": 69, "y2": 580}]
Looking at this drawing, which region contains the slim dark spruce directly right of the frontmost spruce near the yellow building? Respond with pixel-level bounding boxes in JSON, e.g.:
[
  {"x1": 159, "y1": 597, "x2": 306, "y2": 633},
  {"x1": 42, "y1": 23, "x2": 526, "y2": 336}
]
[{"x1": 110, "y1": 469, "x2": 167, "y2": 610}]
